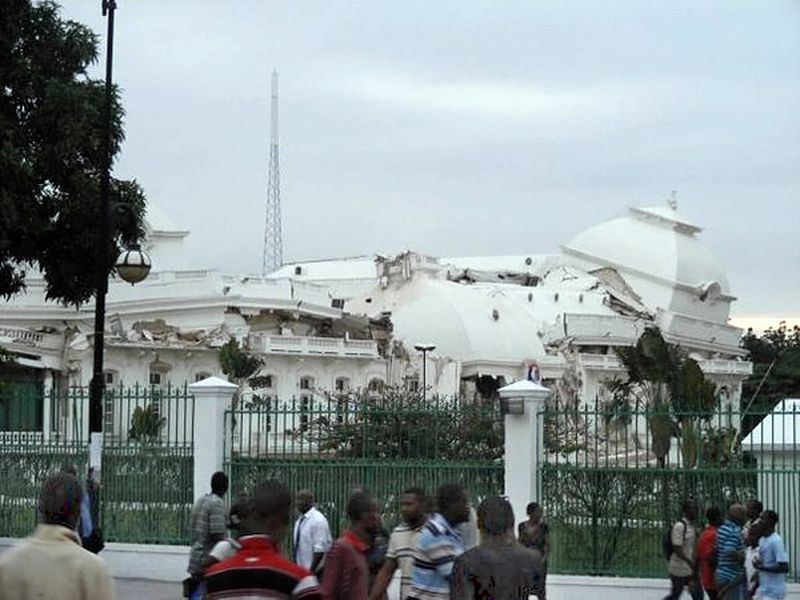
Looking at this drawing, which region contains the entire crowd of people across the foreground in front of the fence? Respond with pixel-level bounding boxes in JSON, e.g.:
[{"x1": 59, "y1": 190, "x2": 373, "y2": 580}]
[{"x1": 0, "y1": 467, "x2": 789, "y2": 600}]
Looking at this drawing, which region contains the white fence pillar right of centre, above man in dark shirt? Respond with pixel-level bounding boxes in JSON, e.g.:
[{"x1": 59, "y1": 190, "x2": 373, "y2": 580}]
[{"x1": 498, "y1": 380, "x2": 550, "y2": 523}]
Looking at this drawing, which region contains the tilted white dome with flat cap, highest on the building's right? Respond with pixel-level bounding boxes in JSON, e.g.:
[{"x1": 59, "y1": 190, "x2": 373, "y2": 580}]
[{"x1": 562, "y1": 205, "x2": 730, "y2": 296}]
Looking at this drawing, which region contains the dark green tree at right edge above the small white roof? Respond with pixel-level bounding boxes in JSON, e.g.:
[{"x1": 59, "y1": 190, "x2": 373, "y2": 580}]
[{"x1": 742, "y1": 321, "x2": 800, "y2": 438}]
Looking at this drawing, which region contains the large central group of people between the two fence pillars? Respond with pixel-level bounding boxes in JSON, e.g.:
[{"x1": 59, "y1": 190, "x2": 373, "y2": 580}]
[{"x1": 185, "y1": 472, "x2": 548, "y2": 600}]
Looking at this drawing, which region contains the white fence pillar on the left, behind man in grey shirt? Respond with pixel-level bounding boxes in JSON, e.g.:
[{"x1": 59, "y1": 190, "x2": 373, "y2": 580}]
[{"x1": 189, "y1": 377, "x2": 239, "y2": 499}]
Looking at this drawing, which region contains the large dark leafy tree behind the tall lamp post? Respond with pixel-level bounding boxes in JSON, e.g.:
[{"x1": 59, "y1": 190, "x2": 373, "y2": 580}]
[{"x1": 0, "y1": 0, "x2": 145, "y2": 305}]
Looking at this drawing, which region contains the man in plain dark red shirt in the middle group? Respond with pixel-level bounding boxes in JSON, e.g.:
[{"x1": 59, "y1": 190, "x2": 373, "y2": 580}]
[{"x1": 322, "y1": 491, "x2": 381, "y2": 600}]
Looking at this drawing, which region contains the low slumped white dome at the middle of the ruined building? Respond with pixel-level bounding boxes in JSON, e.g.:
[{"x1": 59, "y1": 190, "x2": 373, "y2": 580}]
[{"x1": 348, "y1": 276, "x2": 544, "y2": 364}]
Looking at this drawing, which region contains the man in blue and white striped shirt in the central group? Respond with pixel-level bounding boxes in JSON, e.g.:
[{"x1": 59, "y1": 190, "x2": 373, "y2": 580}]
[{"x1": 408, "y1": 484, "x2": 469, "y2": 600}]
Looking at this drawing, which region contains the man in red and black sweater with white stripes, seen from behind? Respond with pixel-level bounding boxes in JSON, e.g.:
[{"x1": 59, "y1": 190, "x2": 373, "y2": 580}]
[{"x1": 206, "y1": 481, "x2": 322, "y2": 600}]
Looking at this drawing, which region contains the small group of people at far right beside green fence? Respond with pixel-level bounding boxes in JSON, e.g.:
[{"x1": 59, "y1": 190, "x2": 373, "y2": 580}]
[{"x1": 665, "y1": 499, "x2": 789, "y2": 600}]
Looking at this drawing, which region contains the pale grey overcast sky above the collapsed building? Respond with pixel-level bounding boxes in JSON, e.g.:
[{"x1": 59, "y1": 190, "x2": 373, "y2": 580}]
[{"x1": 57, "y1": 0, "x2": 800, "y2": 318}]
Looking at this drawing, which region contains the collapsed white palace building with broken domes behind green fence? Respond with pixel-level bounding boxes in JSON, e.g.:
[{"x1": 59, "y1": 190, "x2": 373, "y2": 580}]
[{"x1": 0, "y1": 204, "x2": 751, "y2": 422}]
